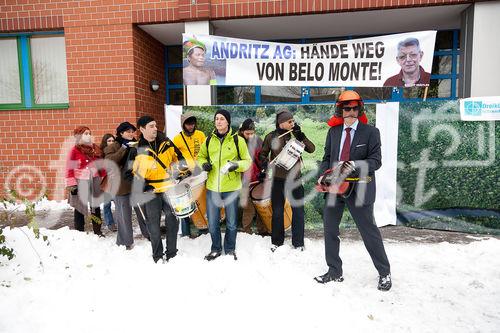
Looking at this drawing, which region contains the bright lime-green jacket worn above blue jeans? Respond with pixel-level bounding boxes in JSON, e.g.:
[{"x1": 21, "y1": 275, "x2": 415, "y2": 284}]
[{"x1": 198, "y1": 129, "x2": 252, "y2": 192}]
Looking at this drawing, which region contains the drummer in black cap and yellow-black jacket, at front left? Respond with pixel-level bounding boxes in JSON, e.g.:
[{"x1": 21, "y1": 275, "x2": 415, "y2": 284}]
[{"x1": 132, "y1": 116, "x2": 185, "y2": 262}]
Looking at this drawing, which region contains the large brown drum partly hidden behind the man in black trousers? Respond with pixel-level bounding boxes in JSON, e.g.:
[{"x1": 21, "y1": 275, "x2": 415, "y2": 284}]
[{"x1": 250, "y1": 182, "x2": 292, "y2": 232}]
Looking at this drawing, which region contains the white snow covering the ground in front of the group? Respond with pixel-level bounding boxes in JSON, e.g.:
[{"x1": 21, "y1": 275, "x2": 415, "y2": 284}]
[{"x1": 0, "y1": 227, "x2": 500, "y2": 333}]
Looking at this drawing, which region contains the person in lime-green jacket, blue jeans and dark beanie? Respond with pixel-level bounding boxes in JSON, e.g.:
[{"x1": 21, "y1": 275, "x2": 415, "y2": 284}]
[{"x1": 198, "y1": 109, "x2": 252, "y2": 261}]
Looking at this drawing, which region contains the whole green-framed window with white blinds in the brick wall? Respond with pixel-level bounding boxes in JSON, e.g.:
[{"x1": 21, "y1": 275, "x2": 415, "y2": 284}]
[{"x1": 0, "y1": 33, "x2": 68, "y2": 109}]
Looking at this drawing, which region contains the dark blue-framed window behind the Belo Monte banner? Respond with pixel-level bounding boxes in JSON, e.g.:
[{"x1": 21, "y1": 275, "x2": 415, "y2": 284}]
[{"x1": 165, "y1": 30, "x2": 460, "y2": 105}]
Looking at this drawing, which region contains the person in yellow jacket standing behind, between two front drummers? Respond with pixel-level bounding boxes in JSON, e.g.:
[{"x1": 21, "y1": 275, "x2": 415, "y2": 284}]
[{"x1": 173, "y1": 112, "x2": 206, "y2": 236}]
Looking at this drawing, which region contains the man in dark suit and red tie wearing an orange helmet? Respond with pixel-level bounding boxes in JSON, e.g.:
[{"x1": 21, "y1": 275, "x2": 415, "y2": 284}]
[{"x1": 315, "y1": 90, "x2": 392, "y2": 291}]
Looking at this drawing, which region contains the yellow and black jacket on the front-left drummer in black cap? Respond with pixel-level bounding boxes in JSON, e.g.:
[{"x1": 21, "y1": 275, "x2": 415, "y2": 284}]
[{"x1": 132, "y1": 137, "x2": 178, "y2": 193}]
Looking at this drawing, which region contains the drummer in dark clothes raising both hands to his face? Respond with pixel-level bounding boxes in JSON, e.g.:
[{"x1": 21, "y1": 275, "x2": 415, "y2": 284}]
[{"x1": 259, "y1": 110, "x2": 316, "y2": 252}]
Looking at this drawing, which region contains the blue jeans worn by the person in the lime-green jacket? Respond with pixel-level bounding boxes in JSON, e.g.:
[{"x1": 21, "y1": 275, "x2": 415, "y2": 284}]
[{"x1": 207, "y1": 190, "x2": 239, "y2": 253}]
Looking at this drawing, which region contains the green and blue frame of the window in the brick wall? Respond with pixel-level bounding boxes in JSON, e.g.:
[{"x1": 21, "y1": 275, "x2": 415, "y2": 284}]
[{"x1": 0, "y1": 31, "x2": 69, "y2": 110}]
